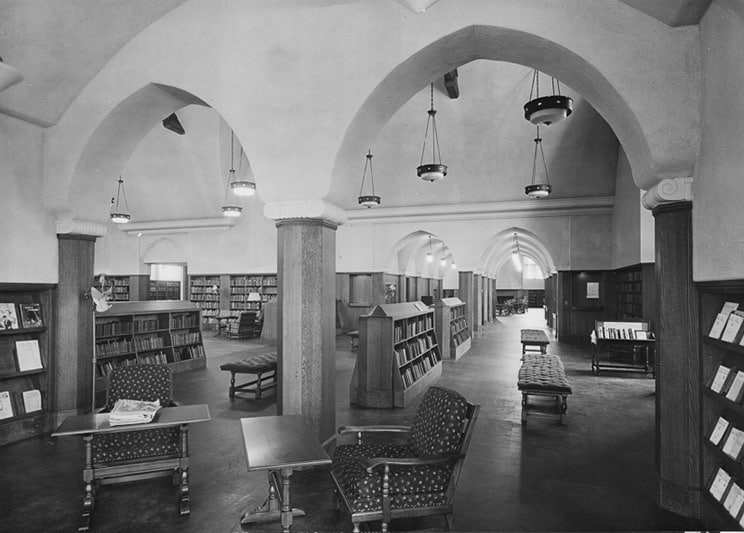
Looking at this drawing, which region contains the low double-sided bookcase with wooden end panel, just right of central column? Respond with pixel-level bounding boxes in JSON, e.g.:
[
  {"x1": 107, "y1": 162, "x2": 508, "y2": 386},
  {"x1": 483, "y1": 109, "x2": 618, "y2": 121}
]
[{"x1": 350, "y1": 302, "x2": 442, "y2": 408}]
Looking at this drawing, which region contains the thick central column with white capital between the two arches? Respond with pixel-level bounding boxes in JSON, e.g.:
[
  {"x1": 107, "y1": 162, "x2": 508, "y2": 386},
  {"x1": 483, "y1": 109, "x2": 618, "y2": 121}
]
[{"x1": 276, "y1": 218, "x2": 337, "y2": 441}]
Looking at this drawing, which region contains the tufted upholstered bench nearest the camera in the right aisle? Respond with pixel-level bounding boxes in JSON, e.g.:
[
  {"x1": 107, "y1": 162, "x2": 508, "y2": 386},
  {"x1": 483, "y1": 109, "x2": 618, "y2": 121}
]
[{"x1": 517, "y1": 354, "x2": 572, "y2": 424}]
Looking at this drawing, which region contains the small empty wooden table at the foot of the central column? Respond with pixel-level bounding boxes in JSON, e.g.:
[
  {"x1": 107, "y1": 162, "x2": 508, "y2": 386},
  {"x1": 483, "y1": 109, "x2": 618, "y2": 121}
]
[{"x1": 240, "y1": 415, "x2": 331, "y2": 533}]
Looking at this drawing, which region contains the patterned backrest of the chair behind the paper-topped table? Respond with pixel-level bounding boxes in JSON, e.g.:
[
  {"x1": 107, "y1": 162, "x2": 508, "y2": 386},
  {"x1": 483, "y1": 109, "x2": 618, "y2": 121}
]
[{"x1": 105, "y1": 364, "x2": 173, "y2": 409}]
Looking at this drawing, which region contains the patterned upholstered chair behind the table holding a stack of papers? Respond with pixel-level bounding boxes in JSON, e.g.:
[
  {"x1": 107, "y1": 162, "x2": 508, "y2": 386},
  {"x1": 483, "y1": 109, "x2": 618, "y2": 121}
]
[{"x1": 92, "y1": 364, "x2": 183, "y2": 492}]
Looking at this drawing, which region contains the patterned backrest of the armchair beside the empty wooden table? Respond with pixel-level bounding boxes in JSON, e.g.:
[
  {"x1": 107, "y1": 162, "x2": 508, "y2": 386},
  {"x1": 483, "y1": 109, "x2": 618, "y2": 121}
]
[{"x1": 408, "y1": 386, "x2": 471, "y2": 457}]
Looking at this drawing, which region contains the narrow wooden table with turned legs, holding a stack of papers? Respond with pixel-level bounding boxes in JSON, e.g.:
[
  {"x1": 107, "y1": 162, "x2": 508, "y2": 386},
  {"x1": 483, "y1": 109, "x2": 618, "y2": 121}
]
[{"x1": 52, "y1": 404, "x2": 211, "y2": 531}]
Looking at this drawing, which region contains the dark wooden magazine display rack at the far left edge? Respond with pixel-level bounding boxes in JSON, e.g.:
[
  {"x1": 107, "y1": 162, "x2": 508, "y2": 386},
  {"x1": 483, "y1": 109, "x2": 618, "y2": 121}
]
[{"x1": 0, "y1": 284, "x2": 54, "y2": 445}]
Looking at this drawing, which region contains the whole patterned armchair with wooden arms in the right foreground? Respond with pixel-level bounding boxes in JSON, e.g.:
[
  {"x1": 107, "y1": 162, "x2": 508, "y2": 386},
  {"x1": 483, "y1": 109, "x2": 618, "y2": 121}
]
[{"x1": 331, "y1": 387, "x2": 480, "y2": 532}]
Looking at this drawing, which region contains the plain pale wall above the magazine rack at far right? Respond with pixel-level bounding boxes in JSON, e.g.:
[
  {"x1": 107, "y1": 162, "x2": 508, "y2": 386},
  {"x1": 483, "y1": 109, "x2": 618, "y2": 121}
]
[{"x1": 692, "y1": 0, "x2": 744, "y2": 281}]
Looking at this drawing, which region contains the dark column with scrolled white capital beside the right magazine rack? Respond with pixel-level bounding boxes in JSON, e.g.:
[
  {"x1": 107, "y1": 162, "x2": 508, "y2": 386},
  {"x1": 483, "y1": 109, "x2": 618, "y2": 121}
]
[{"x1": 644, "y1": 178, "x2": 701, "y2": 517}]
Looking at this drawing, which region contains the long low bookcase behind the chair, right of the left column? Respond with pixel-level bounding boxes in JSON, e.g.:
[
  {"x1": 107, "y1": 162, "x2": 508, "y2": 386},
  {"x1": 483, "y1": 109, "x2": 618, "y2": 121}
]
[{"x1": 94, "y1": 300, "x2": 207, "y2": 402}]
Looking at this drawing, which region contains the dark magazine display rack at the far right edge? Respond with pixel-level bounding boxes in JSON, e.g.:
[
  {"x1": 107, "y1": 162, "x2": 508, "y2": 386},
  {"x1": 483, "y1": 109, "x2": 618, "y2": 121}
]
[{"x1": 698, "y1": 281, "x2": 744, "y2": 530}]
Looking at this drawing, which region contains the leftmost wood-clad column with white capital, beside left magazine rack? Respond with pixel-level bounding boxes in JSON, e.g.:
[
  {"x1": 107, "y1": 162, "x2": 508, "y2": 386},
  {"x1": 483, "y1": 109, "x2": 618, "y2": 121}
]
[{"x1": 53, "y1": 221, "x2": 106, "y2": 418}]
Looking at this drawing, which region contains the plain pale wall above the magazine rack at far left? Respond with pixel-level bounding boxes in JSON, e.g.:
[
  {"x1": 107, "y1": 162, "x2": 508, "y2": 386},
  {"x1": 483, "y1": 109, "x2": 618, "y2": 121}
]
[{"x1": 0, "y1": 114, "x2": 58, "y2": 283}]
